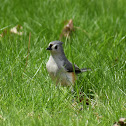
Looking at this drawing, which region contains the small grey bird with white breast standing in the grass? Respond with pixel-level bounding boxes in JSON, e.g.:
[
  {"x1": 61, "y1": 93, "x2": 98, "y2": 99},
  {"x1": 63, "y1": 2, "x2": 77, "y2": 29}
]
[{"x1": 46, "y1": 41, "x2": 91, "y2": 87}]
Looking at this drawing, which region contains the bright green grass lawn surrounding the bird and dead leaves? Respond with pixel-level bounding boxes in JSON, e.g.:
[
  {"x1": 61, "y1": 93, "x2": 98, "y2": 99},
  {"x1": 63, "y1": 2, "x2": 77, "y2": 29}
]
[{"x1": 0, "y1": 0, "x2": 126, "y2": 126}]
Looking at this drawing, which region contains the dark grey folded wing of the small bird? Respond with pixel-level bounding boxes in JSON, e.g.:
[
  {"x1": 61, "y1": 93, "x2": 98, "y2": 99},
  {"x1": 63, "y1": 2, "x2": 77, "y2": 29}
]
[{"x1": 64, "y1": 61, "x2": 81, "y2": 74}]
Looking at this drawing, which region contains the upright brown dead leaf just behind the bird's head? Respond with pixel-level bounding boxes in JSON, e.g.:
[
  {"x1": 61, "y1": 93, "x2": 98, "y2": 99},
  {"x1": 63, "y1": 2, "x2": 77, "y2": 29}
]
[{"x1": 60, "y1": 19, "x2": 74, "y2": 39}]
